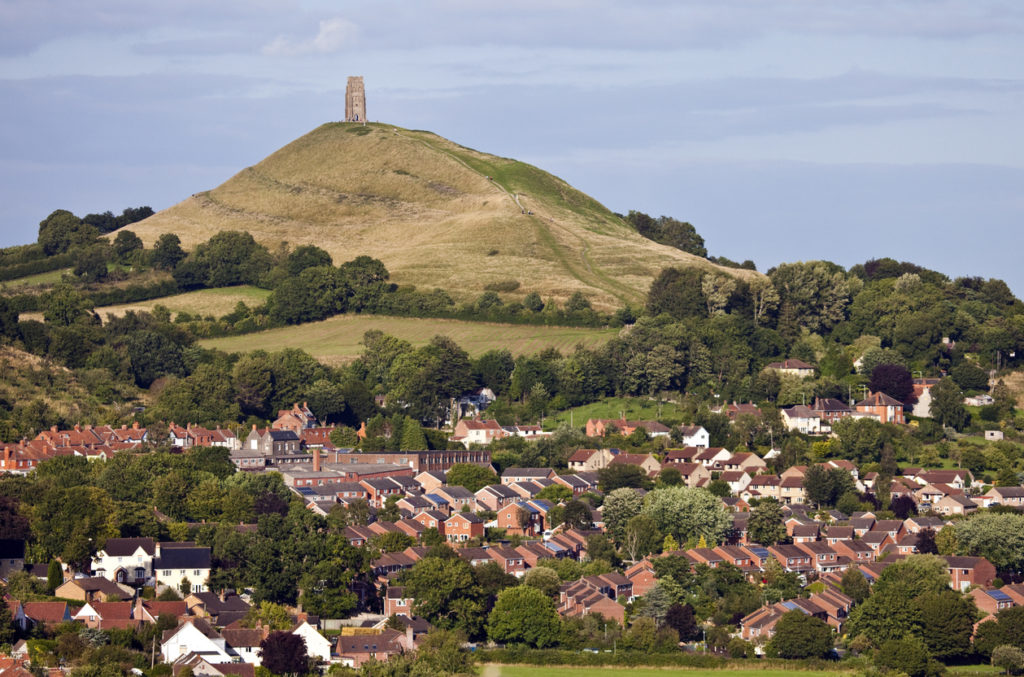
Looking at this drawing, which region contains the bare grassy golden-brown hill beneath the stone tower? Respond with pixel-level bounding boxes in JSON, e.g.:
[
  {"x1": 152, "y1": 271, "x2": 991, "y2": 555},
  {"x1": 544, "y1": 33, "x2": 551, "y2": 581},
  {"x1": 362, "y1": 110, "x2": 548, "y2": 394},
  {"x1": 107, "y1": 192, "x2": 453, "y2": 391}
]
[{"x1": 121, "y1": 123, "x2": 758, "y2": 308}]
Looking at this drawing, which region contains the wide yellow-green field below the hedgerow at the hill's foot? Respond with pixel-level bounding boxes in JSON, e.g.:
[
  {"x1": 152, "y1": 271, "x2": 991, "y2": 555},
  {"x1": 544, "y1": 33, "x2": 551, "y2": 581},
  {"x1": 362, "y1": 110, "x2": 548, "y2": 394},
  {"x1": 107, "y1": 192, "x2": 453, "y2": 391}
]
[{"x1": 201, "y1": 314, "x2": 618, "y2": 364}]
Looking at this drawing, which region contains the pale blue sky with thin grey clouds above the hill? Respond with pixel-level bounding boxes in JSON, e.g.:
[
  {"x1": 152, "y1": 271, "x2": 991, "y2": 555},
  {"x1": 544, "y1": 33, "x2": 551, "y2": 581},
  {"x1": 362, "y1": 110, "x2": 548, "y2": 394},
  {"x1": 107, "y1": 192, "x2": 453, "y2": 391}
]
[{"x1": 0, "y1": 0, "x2": 1024, "y2": 297}]
